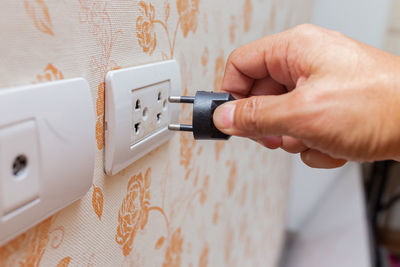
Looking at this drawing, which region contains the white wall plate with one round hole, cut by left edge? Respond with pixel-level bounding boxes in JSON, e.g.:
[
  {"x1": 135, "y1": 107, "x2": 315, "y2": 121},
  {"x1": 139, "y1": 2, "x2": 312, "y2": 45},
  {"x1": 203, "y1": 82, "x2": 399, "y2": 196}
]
[{"x1": 0, "y1": 78, "x2": 96, "y2": 245}]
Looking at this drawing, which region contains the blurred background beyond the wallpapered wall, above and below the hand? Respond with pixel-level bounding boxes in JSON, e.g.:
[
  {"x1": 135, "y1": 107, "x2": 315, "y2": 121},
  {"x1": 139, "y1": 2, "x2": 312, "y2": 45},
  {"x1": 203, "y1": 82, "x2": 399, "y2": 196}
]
[{"x1": 281, "y1": 0, "x2": 400, "y2": 267}]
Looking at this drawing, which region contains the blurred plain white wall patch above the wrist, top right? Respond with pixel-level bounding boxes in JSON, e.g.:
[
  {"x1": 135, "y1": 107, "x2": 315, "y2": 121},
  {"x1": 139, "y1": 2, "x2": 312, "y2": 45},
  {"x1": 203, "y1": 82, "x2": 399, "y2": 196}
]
[{"x1": 311, "y1": 0, "x2": 390, "y2": 48}]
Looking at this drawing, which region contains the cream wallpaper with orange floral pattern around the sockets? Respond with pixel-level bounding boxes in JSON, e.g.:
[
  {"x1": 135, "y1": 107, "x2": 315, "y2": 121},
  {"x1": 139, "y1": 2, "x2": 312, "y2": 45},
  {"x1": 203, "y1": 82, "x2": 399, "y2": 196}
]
[{"x1": 0, "y1": 0, "x2": 313, "y2": 267}]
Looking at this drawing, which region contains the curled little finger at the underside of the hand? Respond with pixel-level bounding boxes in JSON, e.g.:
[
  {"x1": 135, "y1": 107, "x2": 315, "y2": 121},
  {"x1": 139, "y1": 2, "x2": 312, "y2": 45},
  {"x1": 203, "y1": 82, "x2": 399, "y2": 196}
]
[{"x1": 301, "y1": 149, "x2": 347, "y2": 169}]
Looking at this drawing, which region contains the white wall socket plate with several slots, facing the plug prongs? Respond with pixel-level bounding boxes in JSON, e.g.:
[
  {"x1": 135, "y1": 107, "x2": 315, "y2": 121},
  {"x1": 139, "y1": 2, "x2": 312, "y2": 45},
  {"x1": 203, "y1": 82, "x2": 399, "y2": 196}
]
[{"x1": 105, "y1": 60, "x2": 181, "y2": 175}]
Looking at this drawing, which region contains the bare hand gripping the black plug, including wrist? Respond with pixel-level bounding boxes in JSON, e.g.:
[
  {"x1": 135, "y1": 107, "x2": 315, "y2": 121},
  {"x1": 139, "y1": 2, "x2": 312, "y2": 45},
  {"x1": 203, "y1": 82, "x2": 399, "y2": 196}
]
[{"x1": 214, "y1": 25, "x2": 400, "y2": 168}]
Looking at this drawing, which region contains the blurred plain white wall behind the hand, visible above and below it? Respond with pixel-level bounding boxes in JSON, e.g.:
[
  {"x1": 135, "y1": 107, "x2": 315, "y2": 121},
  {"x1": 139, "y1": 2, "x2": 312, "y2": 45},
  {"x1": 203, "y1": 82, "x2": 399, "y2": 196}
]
[{"x1": 287, "y1": 0, "x2": 390, "y2": 232}]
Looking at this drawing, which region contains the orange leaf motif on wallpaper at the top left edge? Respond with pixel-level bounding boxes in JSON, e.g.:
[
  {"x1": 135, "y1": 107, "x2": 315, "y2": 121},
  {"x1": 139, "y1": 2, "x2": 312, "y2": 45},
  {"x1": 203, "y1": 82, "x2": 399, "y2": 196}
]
[{"x1": 25, "y1": 0, "x2": 54, "y2": 35}]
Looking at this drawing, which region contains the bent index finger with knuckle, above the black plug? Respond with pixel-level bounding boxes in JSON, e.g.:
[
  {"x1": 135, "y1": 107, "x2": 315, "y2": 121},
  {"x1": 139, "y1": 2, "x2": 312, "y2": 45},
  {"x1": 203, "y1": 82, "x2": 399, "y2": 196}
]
[{"x1": 222, "y1": 25, "x2": 322, "y2": 98}]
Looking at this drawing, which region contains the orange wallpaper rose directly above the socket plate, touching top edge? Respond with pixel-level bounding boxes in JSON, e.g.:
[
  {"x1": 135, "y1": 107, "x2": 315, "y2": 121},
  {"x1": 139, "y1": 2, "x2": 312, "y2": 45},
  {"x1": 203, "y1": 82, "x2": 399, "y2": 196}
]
[{"x1": 136, "y1": 1, "x2": 157, "y2": 55}]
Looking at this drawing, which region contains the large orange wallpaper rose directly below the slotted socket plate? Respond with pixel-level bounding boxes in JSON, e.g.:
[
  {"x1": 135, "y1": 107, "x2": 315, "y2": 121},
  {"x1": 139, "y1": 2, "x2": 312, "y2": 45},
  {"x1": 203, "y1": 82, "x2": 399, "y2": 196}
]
[{"x1": 115, "y1": 168, "x2": 151, "y2": 256}]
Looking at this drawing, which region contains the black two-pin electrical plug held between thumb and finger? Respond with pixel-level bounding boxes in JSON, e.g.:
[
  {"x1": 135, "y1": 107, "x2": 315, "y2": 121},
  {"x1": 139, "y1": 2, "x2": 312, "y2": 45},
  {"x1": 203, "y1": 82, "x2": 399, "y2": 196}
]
[{"x1": 168, "y1": 91, "x2": 235, "y2": 140}]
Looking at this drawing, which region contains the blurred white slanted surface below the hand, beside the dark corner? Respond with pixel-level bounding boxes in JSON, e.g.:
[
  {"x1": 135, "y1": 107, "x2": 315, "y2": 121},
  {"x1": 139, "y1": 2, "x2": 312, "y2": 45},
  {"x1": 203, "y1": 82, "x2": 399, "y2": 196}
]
[{"x1": 286, "y1": 163, "x2": 371, "y2": 267}]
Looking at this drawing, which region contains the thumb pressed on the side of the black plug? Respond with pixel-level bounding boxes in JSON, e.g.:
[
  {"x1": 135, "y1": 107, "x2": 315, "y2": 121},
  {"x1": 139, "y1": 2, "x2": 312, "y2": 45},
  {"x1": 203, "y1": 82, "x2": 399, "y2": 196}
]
[{"x1": 213, "y1": 92, "x2": 296, "y2": 137}]
